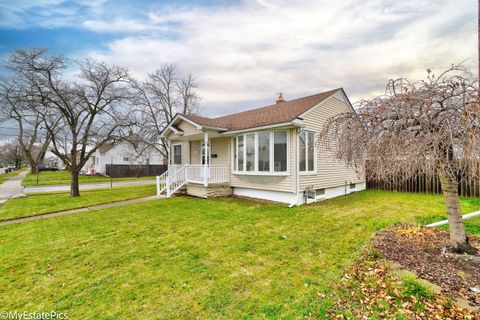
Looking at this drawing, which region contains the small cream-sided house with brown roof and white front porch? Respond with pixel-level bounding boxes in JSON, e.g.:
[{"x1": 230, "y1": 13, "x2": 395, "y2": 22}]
[{"x1": 157, "y1": 89, "x2": 366, "y2": 205}]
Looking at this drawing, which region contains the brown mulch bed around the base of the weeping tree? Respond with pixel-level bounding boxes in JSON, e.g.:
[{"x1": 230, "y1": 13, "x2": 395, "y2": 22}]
[{"x1": 374, "y1": 226, "x2": 480, "y2": 306}]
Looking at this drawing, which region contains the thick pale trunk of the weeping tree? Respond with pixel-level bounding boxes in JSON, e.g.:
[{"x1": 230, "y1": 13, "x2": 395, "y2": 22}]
[{"x1": 439, "y1": 170, "x2": 476, "y2": 254}]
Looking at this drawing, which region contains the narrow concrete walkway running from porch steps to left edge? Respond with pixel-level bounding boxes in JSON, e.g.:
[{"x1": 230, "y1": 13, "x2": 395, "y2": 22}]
[{"x1": 0, "y1": 196, "x2": 165, "y2": 226}]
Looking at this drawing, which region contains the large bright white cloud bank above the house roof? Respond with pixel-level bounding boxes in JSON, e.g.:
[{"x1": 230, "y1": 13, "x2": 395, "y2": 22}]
[{"x1": 86, "y1": 0, "x2": 476, "y2": 115}]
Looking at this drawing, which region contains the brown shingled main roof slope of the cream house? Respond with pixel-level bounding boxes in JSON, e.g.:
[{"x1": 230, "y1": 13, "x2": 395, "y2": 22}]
[{"x1": 181, "y1": 88, "x2": 343, "y2": 130}]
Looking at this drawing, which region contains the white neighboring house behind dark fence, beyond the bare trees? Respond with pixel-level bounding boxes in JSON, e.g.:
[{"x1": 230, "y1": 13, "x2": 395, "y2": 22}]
[{"x1": 83, "y1": 141, "x2": 164, "y2": 175}]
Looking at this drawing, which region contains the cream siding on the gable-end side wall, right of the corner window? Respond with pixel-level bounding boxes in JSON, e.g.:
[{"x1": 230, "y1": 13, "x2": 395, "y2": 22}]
[{"x1": 296, "y1": 96, "x2": 365, "y2": 191}]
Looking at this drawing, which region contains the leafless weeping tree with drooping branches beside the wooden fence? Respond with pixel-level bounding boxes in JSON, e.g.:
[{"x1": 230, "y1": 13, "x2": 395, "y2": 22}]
[{"x1": 320, "y1": 65, "x2": 480, "y2": 254}]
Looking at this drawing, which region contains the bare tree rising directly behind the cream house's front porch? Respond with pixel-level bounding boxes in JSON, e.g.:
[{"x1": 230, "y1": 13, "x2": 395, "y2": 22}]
[{"x1": 131, "y1": 64, "x2": 201, "y2": 159}]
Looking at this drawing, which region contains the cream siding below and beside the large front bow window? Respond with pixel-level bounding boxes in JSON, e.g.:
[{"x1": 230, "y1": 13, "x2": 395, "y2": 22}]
[{"x1": 230, "y1": 129, "x2": 297, "y2": 192}]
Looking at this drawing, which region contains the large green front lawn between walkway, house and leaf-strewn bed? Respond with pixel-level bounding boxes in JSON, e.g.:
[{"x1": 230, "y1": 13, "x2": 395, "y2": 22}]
[{"x1": 0, "y1": 191, "x2": 480, "y2": 319}]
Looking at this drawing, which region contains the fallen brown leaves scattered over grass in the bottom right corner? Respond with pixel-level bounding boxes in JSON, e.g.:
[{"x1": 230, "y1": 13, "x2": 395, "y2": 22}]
[{"x1": 328, "y1": 254, "x2": 480, "y2": 319}]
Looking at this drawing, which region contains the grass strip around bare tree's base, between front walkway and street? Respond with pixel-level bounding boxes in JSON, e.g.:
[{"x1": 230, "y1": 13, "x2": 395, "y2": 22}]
[{"x1": 0, "y1": 185, "x2": 156, "y2": 221}]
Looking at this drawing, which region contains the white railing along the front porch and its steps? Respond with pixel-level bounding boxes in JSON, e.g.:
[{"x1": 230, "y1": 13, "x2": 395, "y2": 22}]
[{"x1": 157, "y1": 164, "x2": 230, "y2": 197}]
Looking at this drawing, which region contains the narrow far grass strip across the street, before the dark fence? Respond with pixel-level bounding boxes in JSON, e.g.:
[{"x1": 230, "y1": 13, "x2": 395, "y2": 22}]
[{"x1": 22, "y1": 171, "x2": 155, "y2": 187}]
